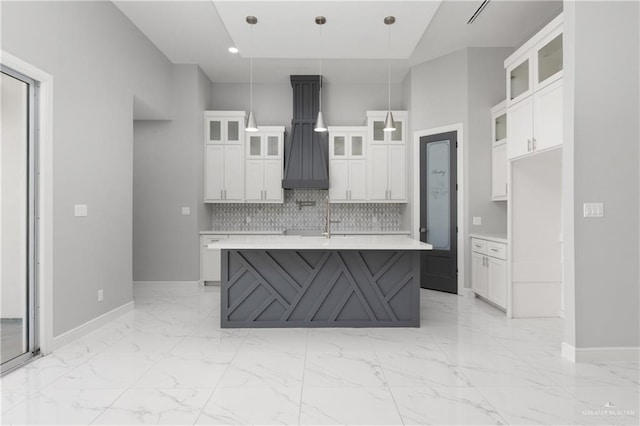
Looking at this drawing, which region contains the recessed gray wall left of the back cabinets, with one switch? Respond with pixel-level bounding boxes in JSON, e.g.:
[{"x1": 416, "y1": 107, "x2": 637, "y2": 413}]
[{"x1": 133, "y1": 65, "x2": 211, "y2": 281}]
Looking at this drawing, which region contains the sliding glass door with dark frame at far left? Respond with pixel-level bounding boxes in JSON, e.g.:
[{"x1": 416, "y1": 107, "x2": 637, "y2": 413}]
[{"x1": 0, "y1": 67, "x2": 38, "y2": 373}]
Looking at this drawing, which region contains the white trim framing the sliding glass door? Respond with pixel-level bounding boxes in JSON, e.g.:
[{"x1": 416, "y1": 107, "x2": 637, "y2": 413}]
[{"x1": 0, "y1": 50, "x2": 54, "y2": 354}]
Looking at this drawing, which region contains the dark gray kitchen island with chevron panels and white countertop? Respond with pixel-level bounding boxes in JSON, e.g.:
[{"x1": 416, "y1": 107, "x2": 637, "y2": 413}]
[{"x1": 209, "y1": 235, "x2": 431, "y2": 328}]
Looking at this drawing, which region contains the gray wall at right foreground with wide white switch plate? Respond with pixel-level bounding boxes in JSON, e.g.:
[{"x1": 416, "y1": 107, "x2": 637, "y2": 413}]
[{"x1": 565, "y1": 1, "x2": 640, "y2": 348}]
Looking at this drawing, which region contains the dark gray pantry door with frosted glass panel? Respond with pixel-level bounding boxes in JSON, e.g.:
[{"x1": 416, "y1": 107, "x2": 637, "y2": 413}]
[{"x1": 420, "y1": 132, "x2": 458, "y2": 293}]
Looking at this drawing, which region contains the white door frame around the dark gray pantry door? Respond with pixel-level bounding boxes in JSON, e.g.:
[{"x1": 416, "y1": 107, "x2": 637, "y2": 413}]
[{"x1": 411, "y1": 123, "x2": 468, "y2": 295}]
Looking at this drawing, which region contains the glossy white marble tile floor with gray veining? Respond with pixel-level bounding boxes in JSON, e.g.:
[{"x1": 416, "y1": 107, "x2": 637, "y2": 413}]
[{"x1": 0, "y1": 284, "x2": 640, "y2": 425}]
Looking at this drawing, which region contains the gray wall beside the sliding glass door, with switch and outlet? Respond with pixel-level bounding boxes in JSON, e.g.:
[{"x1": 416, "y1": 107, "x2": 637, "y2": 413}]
[{"x1": 0, "y1": 2, "x2": 172, "y2": 335}]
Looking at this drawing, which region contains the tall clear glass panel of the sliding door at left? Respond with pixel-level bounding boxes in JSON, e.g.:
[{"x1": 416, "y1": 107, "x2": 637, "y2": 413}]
[{"x1": 0, "y1": 73, "x2": 29, "y2": 364}]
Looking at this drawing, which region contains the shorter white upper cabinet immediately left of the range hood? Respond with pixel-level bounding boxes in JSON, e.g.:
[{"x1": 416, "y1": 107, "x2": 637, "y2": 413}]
[{"x1": 244, "y1": 126, "x2": 284, "y2": 203}]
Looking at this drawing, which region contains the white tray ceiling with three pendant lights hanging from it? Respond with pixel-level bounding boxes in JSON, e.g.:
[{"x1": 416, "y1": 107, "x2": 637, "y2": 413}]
[{"x1": 113, "y1": 0, "x2": 562, "y2": 83}]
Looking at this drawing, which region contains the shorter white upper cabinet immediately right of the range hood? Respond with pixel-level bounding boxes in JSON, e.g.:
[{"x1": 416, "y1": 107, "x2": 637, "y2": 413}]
[{"x1": 328, "y1": 126, "x2": 367, "y2": 203}]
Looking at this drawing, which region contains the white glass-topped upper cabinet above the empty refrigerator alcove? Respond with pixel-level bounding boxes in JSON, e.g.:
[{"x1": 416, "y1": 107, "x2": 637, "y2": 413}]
[{"x1": 505, "y1": 14, "x2": 563, "y2": 160}]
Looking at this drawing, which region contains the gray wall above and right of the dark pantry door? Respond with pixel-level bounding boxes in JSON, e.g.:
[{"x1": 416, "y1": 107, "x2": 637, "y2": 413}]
[{"x1": 405, "y1": 48, "x2": 512, "y2": 287}]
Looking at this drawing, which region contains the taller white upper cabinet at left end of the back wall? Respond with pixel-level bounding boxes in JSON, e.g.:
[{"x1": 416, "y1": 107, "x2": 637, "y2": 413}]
[{"x1": 204, "y1": 111, "x2": 245, "y2": 203}]
